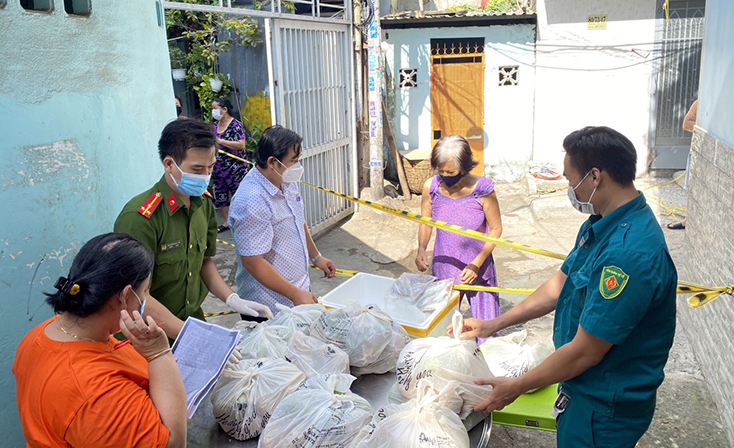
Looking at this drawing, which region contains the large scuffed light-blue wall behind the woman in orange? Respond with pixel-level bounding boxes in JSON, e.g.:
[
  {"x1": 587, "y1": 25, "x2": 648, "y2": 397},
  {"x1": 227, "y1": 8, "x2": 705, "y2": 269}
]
[{"x1": 0, "y1": 0, "x2": 175, "y2": 446}]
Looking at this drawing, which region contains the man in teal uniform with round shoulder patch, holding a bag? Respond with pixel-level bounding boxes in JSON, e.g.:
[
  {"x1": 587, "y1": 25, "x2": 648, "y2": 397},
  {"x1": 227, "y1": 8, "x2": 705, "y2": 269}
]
[{"x1": 461, "y1": 127, "x2": 678, "y2": 448}]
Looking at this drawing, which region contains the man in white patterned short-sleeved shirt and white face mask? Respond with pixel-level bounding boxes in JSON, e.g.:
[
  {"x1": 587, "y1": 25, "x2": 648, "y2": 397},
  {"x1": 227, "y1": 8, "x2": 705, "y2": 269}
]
[{"x1": 229, "y1": 125, "x2": 336, "y2": 313}]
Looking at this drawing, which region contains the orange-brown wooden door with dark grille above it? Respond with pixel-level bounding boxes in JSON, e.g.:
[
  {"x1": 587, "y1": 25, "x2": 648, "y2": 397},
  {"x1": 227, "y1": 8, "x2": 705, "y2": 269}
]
[{"x1": 431, "y1": 38, "x2": 484, "y2": 176}]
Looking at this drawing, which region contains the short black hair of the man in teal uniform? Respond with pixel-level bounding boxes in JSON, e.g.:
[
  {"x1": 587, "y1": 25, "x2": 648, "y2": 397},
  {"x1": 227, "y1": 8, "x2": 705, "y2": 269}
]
[{"x1": 563, "y1": 126, "x2": 637, "y2": 186}]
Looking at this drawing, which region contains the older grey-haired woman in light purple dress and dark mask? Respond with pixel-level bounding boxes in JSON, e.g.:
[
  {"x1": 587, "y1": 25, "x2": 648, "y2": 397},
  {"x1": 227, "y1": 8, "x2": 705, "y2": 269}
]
[{"x1": 415, "y1": 135, "x2": 502, "y2": 343}]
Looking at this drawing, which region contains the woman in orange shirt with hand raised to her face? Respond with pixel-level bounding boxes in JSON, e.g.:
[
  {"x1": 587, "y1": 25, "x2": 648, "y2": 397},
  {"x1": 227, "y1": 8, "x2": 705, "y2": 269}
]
[{"x1": 13, "y1": 233, "x2": 186, "y2": 448}]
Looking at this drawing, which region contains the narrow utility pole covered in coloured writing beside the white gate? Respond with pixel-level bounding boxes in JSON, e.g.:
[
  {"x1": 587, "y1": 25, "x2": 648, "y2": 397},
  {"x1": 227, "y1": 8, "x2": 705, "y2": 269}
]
[{"x1": 367, "y1": 0, "x2": 385, "y2": 200}]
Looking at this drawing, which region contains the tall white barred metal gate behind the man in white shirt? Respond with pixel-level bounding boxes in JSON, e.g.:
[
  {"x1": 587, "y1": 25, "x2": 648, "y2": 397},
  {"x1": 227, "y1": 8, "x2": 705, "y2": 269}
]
[{"x1": 271, "y1": 19, "x2": 357, "y2": 233}]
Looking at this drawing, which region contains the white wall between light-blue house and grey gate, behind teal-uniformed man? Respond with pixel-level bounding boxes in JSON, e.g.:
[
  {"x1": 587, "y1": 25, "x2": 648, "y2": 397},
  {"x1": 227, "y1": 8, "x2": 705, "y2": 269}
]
[{"x1": 534, "y1": 0, "x2": 660, "y2": 173}]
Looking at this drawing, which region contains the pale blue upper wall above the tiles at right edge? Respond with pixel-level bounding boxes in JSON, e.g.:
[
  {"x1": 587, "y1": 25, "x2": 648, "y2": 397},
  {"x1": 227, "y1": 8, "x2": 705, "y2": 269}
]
[{"x1": 696, "y1": 0, "x2": 734, "y2": 147}]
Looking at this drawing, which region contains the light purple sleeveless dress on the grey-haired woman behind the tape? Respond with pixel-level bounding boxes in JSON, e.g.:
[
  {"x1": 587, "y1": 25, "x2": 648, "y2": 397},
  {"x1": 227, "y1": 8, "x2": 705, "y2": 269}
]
[{"x1": 430, "y1": 176, "x2": 500, "y2": 344}]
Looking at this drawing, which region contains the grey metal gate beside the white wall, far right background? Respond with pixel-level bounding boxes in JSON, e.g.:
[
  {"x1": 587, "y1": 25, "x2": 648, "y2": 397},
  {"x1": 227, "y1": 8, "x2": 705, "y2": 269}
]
[{"x1": 650, "y1": 0, "x2": 705, "y2": 169}]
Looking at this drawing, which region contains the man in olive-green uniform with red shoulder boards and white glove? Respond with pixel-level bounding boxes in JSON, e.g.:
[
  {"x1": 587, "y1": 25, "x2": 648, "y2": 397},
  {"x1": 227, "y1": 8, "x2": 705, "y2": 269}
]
[{"x1": 115, "y1": 119, "x2": 272, "y2": 339}]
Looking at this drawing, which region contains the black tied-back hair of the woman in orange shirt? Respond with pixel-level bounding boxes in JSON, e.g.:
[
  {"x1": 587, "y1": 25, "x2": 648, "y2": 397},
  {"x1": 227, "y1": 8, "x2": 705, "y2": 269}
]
[{"x1": 44, "y1": 233, "x2": 155, "y2": 317}]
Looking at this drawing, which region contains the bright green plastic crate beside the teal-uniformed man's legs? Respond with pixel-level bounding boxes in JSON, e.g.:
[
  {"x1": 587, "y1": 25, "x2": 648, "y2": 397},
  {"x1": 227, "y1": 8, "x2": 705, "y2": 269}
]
[{"x1": 492, "y1": 384, "x2": 558, "y2": 432}]
